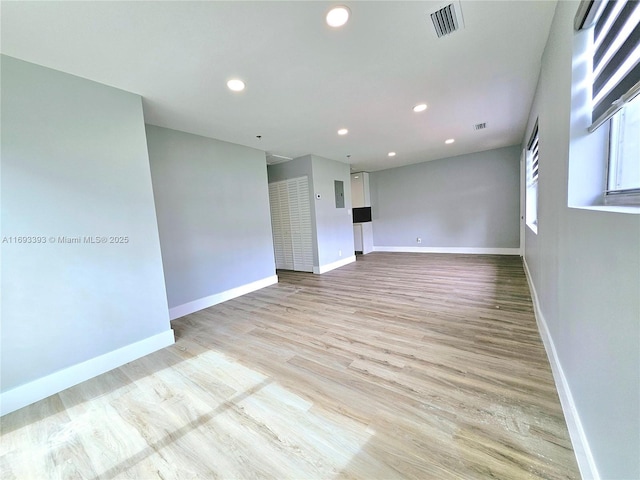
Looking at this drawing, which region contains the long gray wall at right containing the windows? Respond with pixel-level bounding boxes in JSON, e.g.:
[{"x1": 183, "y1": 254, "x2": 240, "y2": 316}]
[{"x1": 525, "y1": 2, "x2": 640, "y2": 479}]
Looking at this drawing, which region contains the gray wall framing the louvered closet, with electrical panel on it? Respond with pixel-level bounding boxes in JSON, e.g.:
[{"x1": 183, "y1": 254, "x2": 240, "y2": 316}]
[{"x1": 268, "y1": 155, "x2": 354, "y2": 267}]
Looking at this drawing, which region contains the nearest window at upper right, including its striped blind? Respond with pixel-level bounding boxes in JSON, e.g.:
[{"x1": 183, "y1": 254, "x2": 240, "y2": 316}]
[{"x1": 575, "y1": 0, "x2": 640, "y2": 205}]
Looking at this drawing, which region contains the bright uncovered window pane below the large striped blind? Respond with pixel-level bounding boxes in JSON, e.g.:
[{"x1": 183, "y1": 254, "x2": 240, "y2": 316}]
[{"x1": 606, "y1": 97, "x2": 640, "y2": 205}]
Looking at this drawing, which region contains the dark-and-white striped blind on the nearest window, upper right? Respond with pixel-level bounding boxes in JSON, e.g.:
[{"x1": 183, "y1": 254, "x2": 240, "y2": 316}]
[{"x1": 575, "y1": 0, "x2": 640, "y2": 131}]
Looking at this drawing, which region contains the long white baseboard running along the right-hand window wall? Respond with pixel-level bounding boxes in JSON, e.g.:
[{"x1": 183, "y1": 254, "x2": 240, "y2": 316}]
[{"x1": 522, "y1": 256, "x2": 600, "y2": 480}]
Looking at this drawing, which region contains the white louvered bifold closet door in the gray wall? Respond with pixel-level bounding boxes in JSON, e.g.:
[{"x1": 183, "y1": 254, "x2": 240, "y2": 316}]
[{"x1": 269, "y1": 177, "x2": 313, "y2": 272}]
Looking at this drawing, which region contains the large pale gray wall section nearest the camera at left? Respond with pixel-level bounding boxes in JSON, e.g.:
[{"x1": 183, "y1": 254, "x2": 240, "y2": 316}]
[{"x1": 0, "y1": 56, "x2": 170, "y2": 392}]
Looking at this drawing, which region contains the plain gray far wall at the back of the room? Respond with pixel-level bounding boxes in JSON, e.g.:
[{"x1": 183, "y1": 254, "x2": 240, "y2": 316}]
[{"x1": 369, "y1": 146, "x2": 520, "y2": 248}]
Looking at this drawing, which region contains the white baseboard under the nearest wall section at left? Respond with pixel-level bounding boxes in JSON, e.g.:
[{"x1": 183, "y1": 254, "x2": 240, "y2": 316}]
[{"x1": 0, "y1": 330, "x2": 175, "y2": 415}]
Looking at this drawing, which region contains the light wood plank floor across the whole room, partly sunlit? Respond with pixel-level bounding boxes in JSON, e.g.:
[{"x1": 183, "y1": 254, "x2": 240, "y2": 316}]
[{"x1": 0, "y1": 253, "x2": 579, "y2": 480}]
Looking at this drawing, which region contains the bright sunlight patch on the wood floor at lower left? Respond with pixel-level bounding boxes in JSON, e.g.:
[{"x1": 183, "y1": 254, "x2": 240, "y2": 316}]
[{"x1": 0, "y1": 351, "x2": 372, "y2": 478}]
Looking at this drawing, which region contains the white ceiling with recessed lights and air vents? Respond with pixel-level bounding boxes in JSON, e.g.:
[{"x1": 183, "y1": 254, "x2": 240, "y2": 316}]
[{"x1": 1, "y1": 0, "x2": 556, "y2": 171}]
